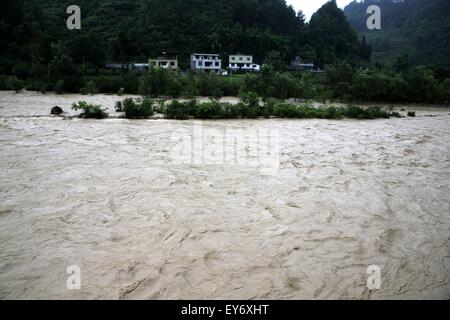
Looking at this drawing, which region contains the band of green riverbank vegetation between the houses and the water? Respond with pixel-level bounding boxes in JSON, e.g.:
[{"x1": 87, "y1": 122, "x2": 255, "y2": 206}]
[{"x1": 4, "y1": 59, "x2": 450, "y2": 104}]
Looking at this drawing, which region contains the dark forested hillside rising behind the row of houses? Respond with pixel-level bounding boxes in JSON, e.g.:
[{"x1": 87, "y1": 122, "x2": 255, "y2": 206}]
[{"x1": 0, "y1": 0, "x2": 370, "y2": 73}]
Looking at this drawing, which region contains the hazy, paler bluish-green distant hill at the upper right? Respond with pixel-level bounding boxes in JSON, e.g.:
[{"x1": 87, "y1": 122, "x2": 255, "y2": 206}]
[{"x1": 344, "y1": 0, "x2": 450, "y2": 69}]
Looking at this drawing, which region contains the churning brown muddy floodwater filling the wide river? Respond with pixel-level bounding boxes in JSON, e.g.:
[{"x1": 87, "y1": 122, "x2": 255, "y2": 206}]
[{"x1": 0, "y1": 92, "x2": 450, "y2": 299}]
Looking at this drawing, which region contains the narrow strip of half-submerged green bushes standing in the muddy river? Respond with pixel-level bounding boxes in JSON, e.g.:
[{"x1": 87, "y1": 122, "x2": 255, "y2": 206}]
[{"x1": 77, "y1": 92, "x2": 404, "y2": 120}]
